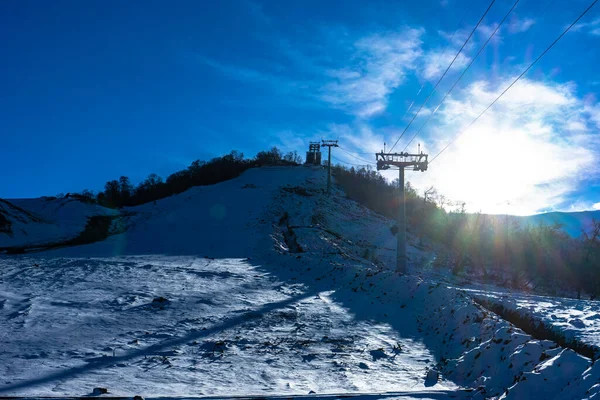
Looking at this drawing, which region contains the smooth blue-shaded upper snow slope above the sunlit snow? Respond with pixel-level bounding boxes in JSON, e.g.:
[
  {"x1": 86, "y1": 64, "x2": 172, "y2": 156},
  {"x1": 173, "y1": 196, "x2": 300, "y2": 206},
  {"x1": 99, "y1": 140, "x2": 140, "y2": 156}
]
[{"x1": 34, "y1": 167, "x2": 322, "y2": 258}]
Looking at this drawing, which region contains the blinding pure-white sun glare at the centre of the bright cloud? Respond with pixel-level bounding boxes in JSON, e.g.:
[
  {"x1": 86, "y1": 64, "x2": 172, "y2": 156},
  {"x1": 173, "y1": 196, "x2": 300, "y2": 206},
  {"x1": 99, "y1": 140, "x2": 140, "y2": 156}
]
[{"x1": 429, "y1": 118, "x2": 588, "y2": 215}]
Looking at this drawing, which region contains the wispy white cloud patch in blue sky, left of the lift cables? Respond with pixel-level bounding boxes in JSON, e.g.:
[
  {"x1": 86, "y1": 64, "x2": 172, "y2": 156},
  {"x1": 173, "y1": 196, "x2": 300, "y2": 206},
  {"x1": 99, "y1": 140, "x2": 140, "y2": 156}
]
[{"x1": 321, "y1": 28, "x2": 423, "y2": 118}]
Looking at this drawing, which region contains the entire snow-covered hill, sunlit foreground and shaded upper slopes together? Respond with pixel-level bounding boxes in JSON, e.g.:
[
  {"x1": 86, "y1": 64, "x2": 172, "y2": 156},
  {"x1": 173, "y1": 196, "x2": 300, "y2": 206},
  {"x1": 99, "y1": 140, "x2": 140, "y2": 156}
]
[{"x1": 0, "y1": 167, "x2": 600, "y2": 399}]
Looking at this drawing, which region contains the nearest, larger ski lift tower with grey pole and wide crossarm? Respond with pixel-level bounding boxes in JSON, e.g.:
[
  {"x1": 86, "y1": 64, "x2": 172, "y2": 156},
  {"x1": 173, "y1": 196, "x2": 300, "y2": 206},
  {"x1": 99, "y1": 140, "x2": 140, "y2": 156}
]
[{"x1": 375, "y1": 151, "x2": 428, "y2": 274}]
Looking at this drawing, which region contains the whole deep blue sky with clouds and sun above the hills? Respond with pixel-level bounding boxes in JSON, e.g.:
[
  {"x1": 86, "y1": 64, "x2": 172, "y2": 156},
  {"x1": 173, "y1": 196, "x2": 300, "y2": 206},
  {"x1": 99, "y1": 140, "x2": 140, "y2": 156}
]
[{"x1": 0, "y1": 0, "x2": 600, "y2": 214}]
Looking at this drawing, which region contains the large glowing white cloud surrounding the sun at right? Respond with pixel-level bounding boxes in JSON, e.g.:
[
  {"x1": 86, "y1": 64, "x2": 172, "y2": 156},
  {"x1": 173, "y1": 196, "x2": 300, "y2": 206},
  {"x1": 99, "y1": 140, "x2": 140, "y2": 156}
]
[{"x1": 407, "y1": 79, "x2": 600, "y2": 215}]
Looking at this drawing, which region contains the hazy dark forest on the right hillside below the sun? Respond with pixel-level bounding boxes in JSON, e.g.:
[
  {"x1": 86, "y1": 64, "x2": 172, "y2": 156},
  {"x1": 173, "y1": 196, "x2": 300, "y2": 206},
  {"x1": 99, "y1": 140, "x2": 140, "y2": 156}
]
[{"x1": 333, "y1": 166, "x2": 600, "y2": 299}]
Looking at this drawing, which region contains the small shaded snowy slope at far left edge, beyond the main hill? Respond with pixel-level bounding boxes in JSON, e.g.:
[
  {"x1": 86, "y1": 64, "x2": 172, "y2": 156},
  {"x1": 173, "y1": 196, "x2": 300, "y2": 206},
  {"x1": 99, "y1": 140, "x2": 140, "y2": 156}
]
[{"x1": 0, "y1": 197, "x2": 117, "y2": 248}]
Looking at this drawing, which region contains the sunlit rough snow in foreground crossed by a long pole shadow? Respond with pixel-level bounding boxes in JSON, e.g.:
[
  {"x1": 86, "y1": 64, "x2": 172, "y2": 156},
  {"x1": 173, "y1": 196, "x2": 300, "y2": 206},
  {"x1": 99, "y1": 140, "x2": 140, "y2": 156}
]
[{"x1": 0, "y1": 256, "x2": 455, "y2": 396}]
